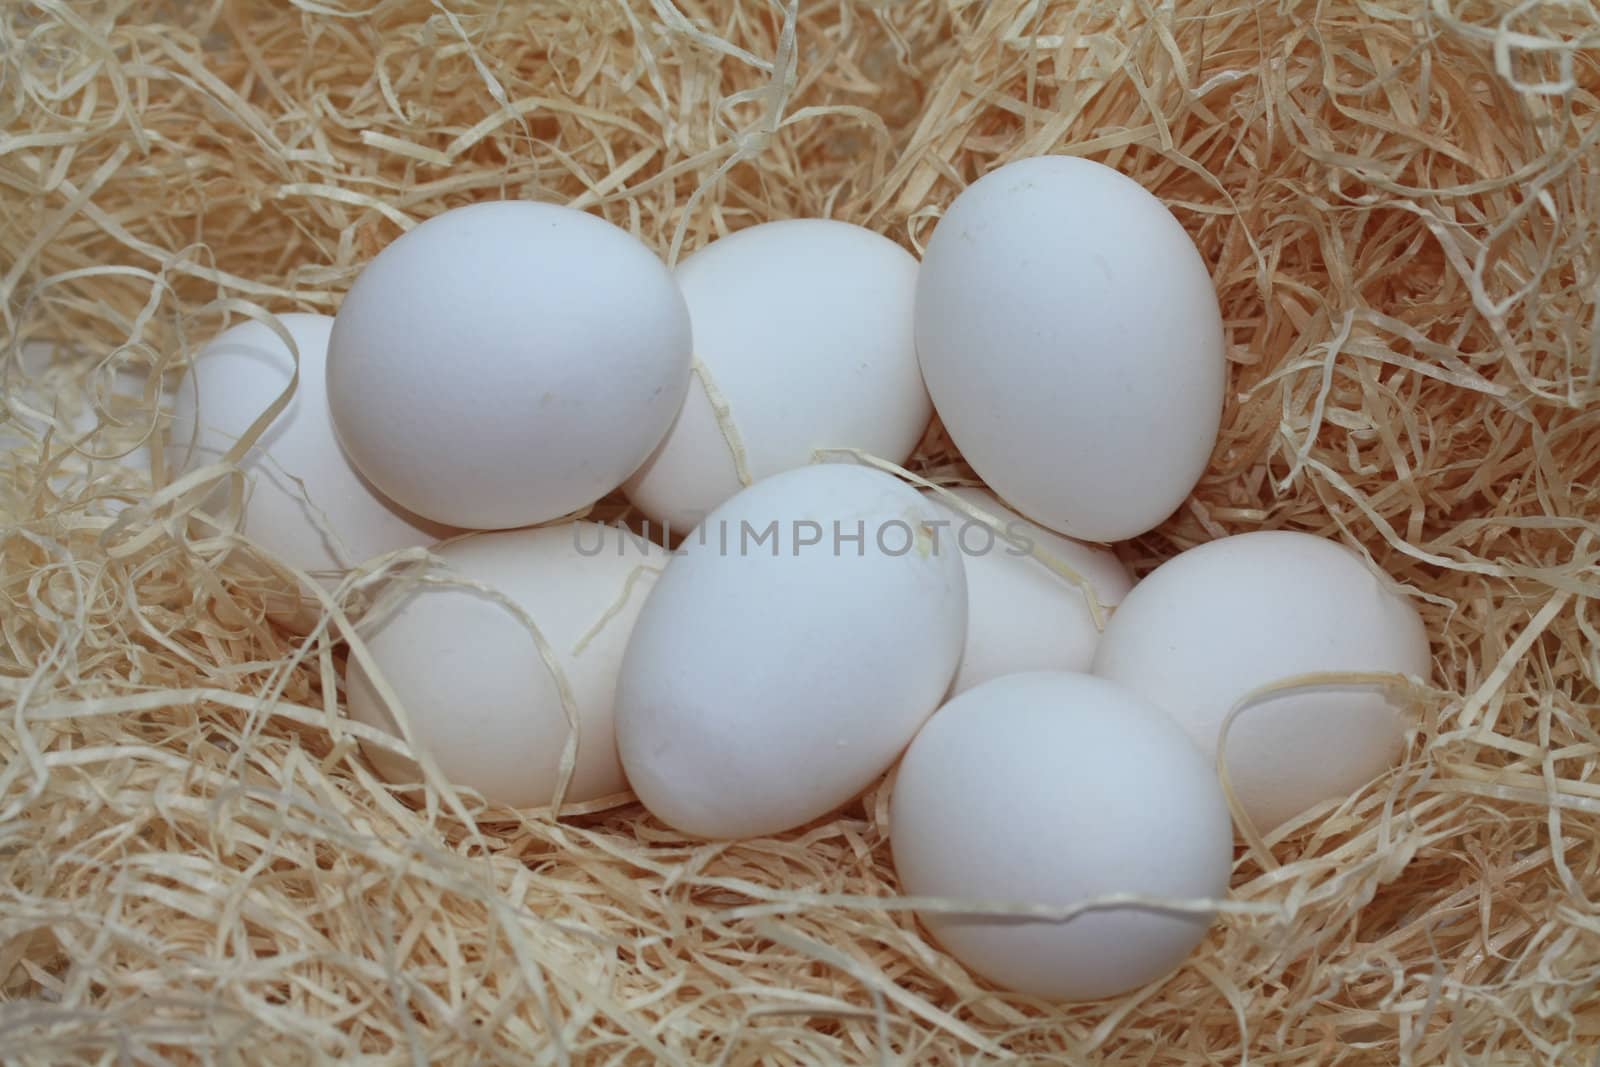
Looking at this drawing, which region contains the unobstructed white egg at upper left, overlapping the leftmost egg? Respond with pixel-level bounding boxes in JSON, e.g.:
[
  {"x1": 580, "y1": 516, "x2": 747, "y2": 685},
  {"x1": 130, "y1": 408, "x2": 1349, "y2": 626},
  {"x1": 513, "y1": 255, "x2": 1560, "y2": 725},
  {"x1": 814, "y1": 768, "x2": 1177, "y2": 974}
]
[{"x1": 328, "y1": 202, "x2": 691, "y2": 530}]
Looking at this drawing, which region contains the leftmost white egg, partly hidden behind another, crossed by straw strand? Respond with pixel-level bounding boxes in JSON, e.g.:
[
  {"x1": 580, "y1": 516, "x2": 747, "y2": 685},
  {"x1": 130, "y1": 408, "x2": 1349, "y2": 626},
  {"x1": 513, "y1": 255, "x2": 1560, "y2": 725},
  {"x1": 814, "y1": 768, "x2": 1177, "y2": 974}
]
[{"x1": 168, "y1": 314, "x2": 454, "y2": 630}]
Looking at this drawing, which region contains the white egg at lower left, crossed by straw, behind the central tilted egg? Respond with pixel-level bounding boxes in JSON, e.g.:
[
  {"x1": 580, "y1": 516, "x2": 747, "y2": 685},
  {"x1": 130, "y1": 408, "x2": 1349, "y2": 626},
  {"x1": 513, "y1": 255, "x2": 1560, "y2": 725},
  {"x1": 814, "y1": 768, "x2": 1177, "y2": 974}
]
[{"x1": 347, "y1": 522, "x2": 669, "y2": 808}]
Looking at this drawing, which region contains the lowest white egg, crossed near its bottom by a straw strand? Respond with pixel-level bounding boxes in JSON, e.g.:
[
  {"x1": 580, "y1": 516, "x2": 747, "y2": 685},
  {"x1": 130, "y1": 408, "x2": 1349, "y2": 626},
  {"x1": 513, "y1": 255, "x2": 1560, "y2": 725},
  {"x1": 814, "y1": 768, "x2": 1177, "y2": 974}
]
[{"x1": 890, "y1": 672, "x2": 1234, "y2": 1000}]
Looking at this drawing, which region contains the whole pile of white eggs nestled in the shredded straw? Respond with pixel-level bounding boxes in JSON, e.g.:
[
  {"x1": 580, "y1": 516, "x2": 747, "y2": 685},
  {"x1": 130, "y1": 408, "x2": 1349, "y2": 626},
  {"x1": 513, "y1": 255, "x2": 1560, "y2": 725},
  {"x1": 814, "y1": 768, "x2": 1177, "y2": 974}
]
[{"x1": 173, "y1": 157, "x2": 1429, "y2": 998}]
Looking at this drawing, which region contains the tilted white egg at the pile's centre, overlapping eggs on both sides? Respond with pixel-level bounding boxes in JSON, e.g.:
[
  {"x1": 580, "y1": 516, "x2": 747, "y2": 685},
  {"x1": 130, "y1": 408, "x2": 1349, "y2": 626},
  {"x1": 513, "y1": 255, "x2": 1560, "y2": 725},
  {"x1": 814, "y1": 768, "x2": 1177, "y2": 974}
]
[{"x1": 616, "y1": 464, "x2": 966, "y2": 838}]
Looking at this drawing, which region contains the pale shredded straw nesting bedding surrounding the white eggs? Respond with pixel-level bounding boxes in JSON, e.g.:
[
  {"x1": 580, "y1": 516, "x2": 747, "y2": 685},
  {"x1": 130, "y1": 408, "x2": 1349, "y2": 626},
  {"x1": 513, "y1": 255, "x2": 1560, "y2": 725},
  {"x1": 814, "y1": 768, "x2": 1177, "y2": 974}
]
[{"x1": 0, "y1": 0, "x2": 1600, "y2": 1065}]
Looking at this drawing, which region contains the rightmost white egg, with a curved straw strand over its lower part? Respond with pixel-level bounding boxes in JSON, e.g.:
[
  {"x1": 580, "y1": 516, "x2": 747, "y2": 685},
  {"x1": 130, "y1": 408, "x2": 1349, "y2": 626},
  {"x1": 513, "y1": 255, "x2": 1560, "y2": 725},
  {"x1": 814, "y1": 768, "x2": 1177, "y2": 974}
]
[{"x1": 1094, "y1": 531, "x2": 1430, "y2": 830}]
